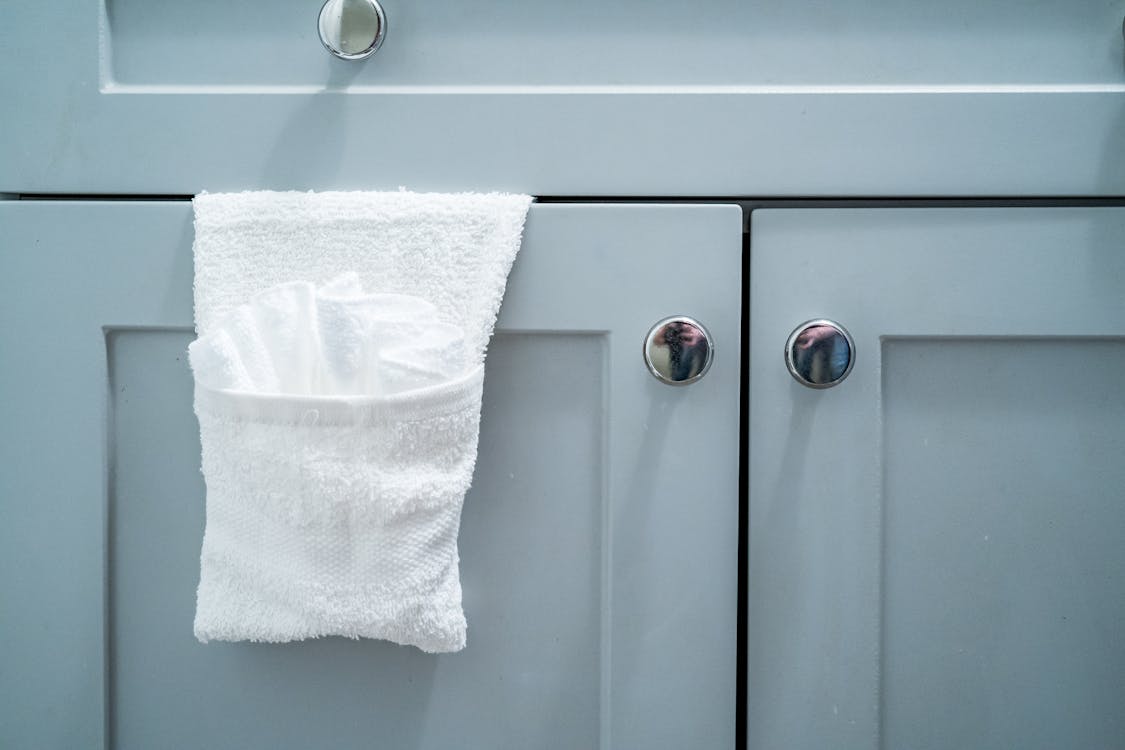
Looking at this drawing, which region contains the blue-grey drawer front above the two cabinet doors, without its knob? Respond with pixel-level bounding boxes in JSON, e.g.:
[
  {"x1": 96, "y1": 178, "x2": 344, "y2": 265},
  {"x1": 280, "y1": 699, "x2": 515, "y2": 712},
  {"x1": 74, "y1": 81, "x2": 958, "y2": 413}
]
[{"x1": 0, "y1": 0, "x2": 1125, "y2": 197}]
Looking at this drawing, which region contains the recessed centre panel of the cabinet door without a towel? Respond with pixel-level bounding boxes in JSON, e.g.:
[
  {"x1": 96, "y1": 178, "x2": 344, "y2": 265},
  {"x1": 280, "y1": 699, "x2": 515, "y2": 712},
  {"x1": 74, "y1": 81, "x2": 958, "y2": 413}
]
[{"x1": 882, "y1": 337, "x2": 1125, "y2": 750}]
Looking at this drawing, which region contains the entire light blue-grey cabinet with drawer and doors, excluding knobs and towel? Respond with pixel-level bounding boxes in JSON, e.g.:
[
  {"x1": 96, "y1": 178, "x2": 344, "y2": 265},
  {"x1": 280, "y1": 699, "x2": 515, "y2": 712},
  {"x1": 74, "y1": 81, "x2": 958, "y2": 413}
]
[{"x1": 0, "y1": 0, "x2": 1125, "y2": 750}]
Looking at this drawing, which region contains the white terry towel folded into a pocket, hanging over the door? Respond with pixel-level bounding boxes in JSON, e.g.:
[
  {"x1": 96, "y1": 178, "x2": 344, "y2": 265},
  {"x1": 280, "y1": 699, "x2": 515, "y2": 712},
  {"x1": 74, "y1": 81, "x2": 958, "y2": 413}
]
[{"x1": 189, "y1": 191, "x2": 531, "y2": 652}]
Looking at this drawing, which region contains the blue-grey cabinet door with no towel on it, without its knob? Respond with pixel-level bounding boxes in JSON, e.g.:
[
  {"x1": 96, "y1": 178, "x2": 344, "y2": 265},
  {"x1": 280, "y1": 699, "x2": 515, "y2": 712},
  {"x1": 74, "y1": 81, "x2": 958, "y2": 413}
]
[{"x1": 748, "y1": 208, "x2": 1125, "y2": 750}]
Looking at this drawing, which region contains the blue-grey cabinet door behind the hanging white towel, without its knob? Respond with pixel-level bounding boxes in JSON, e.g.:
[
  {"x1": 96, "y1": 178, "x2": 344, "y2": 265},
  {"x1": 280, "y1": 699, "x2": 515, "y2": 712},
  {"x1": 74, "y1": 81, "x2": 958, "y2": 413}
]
[{"x1": 0, "y1": 201, "x2": 741, "y2": 748}]
